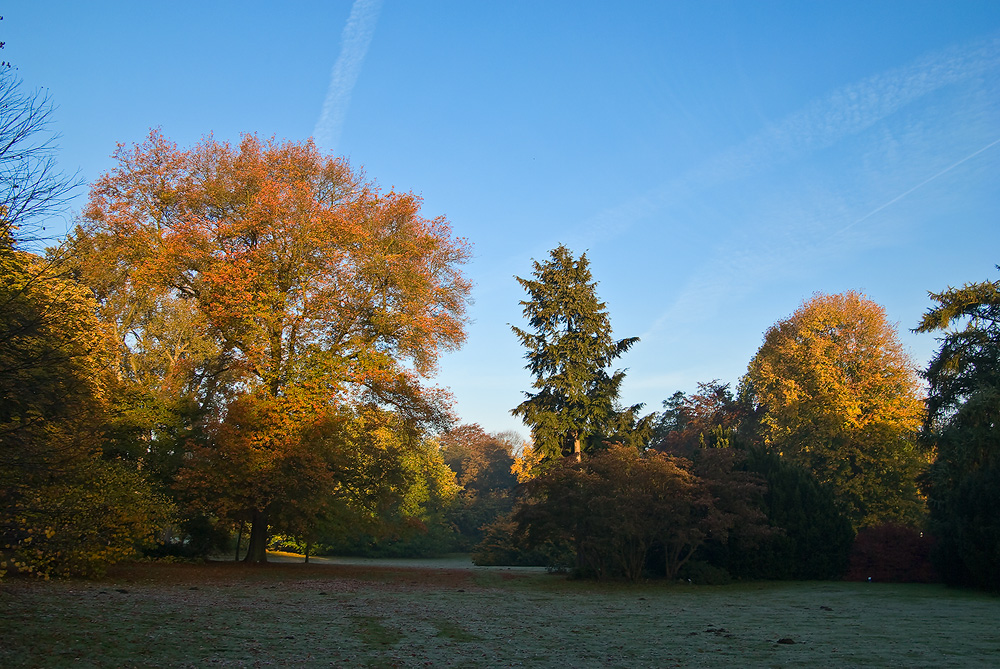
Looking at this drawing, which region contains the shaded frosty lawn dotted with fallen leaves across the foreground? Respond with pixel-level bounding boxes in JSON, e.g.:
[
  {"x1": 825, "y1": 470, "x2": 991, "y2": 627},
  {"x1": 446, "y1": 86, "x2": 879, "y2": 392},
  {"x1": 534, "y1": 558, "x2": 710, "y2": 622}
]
[{"x1": 0, "y1": 563, "x2": 1000, "y2": 667}]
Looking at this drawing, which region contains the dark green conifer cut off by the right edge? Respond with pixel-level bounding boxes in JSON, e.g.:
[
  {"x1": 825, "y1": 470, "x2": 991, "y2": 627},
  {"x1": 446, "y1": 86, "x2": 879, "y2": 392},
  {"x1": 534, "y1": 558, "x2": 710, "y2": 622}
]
[{"x1": 917, "y1": 268, "x2": 1000, "y2": 590}]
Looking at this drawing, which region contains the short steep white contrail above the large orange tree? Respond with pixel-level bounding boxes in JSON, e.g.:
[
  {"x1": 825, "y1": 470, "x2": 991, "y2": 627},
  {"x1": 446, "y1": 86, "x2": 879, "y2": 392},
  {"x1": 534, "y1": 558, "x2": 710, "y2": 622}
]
[{"x1": 313, "y1": 0, "x2": 382, "y2": 153}]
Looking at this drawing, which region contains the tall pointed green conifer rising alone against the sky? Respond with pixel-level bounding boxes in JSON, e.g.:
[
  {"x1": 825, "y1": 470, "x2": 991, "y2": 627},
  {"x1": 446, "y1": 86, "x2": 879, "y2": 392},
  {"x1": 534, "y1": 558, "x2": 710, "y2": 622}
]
[{"x1": 511, "y1": 245, "x2": 642, "y2": 460}]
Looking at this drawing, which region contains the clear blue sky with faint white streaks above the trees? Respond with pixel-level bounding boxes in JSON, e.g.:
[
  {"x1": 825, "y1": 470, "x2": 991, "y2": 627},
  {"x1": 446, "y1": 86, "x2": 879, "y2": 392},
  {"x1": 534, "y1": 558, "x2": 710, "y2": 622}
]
[{"x1": 7, "y1": 0, "x2": 1000, "y2": 434}]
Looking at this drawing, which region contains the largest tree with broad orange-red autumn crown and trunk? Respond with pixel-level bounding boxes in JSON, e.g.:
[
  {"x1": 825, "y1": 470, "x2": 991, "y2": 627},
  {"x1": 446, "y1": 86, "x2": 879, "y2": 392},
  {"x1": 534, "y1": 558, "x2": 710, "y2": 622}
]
[{"x1": 72, "y1": 131, "x2": 469, "y2": 560}]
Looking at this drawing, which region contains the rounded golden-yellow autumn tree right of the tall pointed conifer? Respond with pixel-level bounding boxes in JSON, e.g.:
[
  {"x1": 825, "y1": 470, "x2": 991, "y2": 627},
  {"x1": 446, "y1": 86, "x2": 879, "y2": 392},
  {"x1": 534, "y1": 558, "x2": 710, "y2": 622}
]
[{"x1": 741, "y1": 292, "x2": 927, "y2": 528}]
